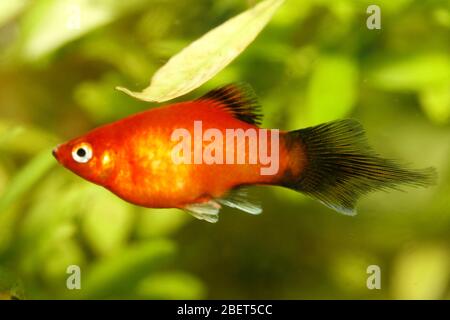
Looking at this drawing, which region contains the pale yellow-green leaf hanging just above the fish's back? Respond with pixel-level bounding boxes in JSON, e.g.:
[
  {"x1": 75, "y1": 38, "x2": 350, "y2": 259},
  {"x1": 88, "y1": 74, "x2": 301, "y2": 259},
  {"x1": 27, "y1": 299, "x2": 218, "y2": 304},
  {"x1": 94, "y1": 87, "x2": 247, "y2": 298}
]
[{"x1": 117, "y1": 0, "x2": 284, "y2": 102}]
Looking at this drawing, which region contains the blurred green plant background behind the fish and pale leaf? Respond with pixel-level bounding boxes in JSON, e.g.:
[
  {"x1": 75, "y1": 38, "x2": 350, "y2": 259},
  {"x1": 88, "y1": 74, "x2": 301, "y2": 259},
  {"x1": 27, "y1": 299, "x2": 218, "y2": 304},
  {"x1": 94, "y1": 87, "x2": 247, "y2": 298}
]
[{"x1": 0, "y1": 0, "x2": 450, "y2": 299}]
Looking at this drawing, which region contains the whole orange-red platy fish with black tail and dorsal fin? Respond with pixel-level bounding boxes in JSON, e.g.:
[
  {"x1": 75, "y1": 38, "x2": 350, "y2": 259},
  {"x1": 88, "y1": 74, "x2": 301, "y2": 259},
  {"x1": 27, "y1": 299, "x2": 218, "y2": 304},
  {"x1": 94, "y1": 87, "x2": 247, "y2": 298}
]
[{"x1": 53, "y1": 84, "x2": 436, "y2": 222}]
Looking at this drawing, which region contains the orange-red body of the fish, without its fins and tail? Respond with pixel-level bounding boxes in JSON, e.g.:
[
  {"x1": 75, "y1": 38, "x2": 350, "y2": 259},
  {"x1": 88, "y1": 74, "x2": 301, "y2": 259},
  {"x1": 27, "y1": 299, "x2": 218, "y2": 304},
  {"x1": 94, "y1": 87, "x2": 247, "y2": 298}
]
[{"x1": 58, "y1": 100, "x2": 285, "y2": 208}]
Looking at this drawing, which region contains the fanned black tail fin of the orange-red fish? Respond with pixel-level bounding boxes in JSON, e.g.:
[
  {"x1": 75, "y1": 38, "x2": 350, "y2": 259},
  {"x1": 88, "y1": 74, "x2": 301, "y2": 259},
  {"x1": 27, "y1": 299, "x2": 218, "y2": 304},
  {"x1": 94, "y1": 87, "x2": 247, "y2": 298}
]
[{"x1": 282, "y1": 120, "x2": 437, "y2": 215}]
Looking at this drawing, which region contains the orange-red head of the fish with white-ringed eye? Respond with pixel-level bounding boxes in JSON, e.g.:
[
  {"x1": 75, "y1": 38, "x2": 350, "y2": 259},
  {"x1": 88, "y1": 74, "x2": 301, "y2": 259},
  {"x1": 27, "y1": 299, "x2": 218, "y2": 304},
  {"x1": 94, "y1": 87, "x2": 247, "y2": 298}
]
[{"x1": 52, "y1": 132, "x2": 117, "y2": 186}]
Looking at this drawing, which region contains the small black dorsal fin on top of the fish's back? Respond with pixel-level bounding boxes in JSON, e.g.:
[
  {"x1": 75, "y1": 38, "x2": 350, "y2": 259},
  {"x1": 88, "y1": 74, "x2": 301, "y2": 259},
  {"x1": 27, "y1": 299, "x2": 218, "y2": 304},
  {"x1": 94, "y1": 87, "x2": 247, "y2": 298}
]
[{"x1": 197, "y1": 83, "x2": 262, "y2": 125}]
